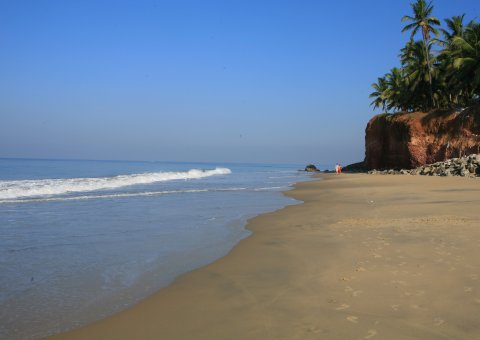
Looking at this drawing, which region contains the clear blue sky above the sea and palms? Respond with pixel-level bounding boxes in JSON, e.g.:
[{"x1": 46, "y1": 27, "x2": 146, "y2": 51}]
[{"x1": 0, "y1": 0, "x2": 480, "y2": 164}]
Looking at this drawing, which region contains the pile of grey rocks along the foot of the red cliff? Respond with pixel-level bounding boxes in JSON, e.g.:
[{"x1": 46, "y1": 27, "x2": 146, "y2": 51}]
[{"x1": 368, "y1": 154, "x2": 480, "y2": 177}]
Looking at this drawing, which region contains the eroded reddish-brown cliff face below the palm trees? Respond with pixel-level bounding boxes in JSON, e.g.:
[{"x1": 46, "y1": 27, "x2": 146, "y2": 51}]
[{"x1": 365, "y1": 105, "x2": 480, "y2": 169}]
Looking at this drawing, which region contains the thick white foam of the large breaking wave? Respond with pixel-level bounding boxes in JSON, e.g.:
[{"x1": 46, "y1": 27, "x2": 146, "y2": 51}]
[{"x1": 0, "y1": 168, "x2": 231, "y2": 200}]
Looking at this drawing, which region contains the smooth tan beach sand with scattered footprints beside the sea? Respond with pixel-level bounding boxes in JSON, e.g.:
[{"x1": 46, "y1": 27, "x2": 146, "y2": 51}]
[{"x1": 51, "y1": 174, "x2": 480, "y2": 339}]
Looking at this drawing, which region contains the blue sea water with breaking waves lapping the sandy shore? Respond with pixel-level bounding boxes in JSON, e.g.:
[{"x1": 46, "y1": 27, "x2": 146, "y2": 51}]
[{"x1": 0, "y1": 159, "x2": 314, "y2": 339}]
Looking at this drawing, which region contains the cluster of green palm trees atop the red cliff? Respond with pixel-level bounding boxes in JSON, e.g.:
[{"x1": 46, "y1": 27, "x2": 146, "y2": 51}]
[{"x1": 370, "y1": 0, "x2": 480, "y2": 112}]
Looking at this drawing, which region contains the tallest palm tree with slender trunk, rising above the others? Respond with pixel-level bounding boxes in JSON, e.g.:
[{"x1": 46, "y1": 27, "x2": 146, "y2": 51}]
[{"x1": 402, "y1": 0, "x2": 440, "y2": 107}]
